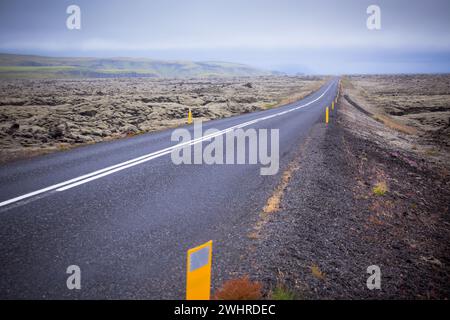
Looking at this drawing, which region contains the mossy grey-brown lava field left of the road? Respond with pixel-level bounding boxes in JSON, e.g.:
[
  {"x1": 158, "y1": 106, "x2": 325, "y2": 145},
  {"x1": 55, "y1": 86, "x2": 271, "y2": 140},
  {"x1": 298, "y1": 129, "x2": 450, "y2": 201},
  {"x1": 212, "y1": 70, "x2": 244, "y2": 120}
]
[{"x1": 0, "y1": 76, "x2": 325, "y2": 162}]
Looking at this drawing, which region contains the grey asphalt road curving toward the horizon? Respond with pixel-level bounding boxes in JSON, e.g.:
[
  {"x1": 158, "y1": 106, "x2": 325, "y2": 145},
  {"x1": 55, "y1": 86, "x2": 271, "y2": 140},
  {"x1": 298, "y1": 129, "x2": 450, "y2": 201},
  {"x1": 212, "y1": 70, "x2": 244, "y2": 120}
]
[{"x1": 0, "y1": 79, "x2": 338, "y2": 299}]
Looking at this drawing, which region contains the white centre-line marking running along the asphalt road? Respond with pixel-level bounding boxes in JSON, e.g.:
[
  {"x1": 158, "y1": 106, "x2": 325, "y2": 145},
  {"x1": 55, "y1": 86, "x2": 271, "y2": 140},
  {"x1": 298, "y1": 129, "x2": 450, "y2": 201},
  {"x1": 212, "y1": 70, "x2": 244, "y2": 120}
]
[{"x1": 0, "y1": 84, "x2": 333, "y2": 207}]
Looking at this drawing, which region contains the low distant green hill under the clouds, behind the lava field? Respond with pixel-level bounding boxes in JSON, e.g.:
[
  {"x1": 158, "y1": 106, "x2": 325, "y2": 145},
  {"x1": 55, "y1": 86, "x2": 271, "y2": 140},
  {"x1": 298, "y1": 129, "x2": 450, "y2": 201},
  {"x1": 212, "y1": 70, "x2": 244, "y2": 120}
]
[{"x1": 0, "y1": 53, "x2": 278, "y2": 78}]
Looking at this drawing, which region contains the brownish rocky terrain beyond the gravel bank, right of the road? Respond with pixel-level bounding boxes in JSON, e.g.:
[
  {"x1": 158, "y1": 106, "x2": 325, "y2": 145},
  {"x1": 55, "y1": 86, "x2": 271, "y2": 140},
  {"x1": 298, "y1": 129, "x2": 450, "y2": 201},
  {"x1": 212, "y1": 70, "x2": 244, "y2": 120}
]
[{"x1": 344, "y1": 75, "x2": 450, "y2": 164}]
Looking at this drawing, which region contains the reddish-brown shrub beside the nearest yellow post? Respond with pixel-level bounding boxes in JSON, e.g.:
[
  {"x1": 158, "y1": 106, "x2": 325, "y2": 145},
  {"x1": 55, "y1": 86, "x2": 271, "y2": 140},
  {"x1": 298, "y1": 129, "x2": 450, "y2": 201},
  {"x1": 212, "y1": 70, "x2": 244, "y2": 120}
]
[{"x1": 213, "y1": 276, "x2": 262, "y2": 300}]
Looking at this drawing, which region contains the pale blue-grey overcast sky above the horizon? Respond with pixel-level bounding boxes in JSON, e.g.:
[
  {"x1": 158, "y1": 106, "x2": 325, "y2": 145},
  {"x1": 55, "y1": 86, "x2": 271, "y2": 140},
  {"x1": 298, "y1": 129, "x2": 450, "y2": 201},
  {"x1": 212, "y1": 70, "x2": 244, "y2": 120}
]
[{"x1": 0, "y1": 0, "x2": 450, "y2": 74}]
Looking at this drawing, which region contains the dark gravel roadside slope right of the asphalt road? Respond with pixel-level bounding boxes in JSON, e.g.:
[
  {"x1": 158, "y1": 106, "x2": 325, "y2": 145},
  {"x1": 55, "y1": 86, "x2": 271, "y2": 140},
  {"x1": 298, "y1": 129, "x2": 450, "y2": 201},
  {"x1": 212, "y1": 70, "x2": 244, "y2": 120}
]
[{"x1": 236, "y1": 94, "x2": 450, "y2": 299}]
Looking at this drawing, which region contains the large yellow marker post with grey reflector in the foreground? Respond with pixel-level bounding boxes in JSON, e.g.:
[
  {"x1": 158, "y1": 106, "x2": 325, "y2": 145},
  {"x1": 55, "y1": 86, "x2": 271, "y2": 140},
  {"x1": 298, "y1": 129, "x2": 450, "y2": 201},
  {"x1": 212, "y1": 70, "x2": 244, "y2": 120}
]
[{"x1": 186, "y1": 240, "x2": 212, "y2": 300}]
